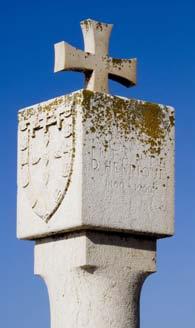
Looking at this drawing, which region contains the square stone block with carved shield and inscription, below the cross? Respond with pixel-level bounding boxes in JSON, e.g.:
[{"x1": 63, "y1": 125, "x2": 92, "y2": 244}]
[{"x1": 17, "y1": 90, "x2": 174, "y2": 239}]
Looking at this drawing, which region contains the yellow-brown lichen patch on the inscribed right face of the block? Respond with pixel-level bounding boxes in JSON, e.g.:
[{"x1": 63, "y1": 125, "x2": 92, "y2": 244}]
[{"x1": 82, "y1": 90, "x2": 174, "y2": 156}]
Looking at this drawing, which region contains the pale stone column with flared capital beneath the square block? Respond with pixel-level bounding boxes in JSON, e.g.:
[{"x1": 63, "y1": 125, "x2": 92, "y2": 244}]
[{"x1": 35, "y1": 232, "x2": 156, "y2": 328}]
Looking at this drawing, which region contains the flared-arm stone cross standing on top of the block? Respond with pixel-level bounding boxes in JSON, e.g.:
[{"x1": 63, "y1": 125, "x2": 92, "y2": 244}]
[{"x1": 54, "y1": 19, "x2": 136, "y2": 93}]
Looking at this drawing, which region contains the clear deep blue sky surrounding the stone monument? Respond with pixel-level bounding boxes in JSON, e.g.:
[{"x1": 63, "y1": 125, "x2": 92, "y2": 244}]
[{"x1": 0, "y1": 0, "x2": 195, "y2": 328}]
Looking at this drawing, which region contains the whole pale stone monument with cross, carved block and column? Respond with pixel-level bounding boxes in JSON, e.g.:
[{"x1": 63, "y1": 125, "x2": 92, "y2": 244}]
[{"x1": 17, "y1": 20, "x2": 174, "y2": 328}]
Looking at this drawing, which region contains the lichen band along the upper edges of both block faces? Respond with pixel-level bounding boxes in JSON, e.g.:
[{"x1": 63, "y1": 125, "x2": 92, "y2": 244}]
[{"x1": 18, "y1": 90, "x2": 174, "y2": 157}]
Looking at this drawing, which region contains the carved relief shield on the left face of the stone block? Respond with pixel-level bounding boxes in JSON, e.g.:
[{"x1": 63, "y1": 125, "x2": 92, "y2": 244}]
[{"x1": 19, "y1": 105, "x2": 74, "y2": 222}]
